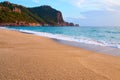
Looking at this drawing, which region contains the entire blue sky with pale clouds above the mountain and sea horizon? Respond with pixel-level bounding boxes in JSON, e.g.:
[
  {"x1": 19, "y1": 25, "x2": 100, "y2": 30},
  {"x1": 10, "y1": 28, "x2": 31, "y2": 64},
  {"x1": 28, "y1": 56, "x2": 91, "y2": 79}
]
[{"x1": 0, "y1": 0, "x2": 120, "y2": 26}]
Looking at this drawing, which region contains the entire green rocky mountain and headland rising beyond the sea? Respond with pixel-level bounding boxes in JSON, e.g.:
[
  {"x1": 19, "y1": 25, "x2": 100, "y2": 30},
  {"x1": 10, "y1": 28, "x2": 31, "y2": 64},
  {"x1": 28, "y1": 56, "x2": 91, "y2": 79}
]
[{"x1": 0, "y1": 1, "x2": 77, "y2": 26}]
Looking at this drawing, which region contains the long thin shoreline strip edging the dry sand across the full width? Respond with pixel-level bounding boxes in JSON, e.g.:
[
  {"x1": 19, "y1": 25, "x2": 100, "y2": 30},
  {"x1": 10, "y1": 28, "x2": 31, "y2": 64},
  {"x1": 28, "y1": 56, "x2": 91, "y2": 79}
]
[{"x1": 0, "y1": 27, "x2": 120, "y2": 56}]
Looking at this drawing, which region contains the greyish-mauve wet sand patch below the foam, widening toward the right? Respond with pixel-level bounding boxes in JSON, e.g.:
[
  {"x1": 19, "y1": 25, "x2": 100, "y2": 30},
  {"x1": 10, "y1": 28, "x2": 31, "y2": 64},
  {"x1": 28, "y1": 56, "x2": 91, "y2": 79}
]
[{"x1": 53, "y1": 39, "x2": 120, "y2": 56}]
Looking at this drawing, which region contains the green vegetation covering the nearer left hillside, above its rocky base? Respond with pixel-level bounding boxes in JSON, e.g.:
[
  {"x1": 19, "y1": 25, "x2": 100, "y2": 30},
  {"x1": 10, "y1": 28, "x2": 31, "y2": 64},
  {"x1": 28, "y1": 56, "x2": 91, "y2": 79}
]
[{"x1": 0, "y1": 2, "x2": 37, "y2": 23}]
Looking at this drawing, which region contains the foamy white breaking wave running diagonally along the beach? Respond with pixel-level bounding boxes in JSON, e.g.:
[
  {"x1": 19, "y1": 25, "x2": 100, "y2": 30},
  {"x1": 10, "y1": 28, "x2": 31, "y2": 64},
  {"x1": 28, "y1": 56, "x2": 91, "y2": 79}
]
[{"x1": 2, "y1": 27, "x2": 120, "y2": 49}]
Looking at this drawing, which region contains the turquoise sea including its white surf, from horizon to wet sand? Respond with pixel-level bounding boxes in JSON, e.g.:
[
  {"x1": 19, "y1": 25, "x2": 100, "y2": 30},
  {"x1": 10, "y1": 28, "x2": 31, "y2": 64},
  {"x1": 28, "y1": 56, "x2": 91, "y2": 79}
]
[{"x1": 7, "y1": 26, "x2": 120, "y2": 48}]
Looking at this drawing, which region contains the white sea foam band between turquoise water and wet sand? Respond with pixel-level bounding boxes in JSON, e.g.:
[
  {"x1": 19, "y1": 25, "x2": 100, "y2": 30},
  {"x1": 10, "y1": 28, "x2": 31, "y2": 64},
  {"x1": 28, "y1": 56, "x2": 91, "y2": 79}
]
[{"x1": 3, "y1": 29, "x2": 120, "y2": 48}]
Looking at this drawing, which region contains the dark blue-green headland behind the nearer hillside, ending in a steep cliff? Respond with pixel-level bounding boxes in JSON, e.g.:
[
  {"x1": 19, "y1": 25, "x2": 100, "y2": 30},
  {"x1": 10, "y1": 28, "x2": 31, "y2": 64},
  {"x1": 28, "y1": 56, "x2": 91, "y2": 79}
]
[{"x1": 28, "y1": 6, "x2": 64, "y2": 25}]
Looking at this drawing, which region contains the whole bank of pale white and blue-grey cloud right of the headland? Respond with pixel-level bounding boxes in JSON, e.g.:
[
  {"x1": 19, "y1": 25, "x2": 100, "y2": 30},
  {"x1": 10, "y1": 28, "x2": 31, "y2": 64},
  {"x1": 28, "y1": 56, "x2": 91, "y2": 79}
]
[{"x1": 62, "y1": 0, "x2": 120, "y2": 26}]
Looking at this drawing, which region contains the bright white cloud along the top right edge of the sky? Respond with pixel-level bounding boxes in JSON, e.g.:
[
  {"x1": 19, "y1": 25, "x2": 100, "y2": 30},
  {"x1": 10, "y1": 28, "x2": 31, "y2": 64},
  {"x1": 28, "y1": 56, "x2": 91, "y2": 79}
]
[{"x1": 68, "y1": 0, "x2": 120, "y2": 11}]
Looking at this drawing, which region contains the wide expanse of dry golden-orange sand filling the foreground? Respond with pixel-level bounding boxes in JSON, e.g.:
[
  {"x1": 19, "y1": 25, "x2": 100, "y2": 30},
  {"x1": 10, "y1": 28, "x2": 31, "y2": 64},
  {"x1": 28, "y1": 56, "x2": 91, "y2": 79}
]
[{"x1": 0, "y1": 29, "x2": 120, "y2": 80}]
